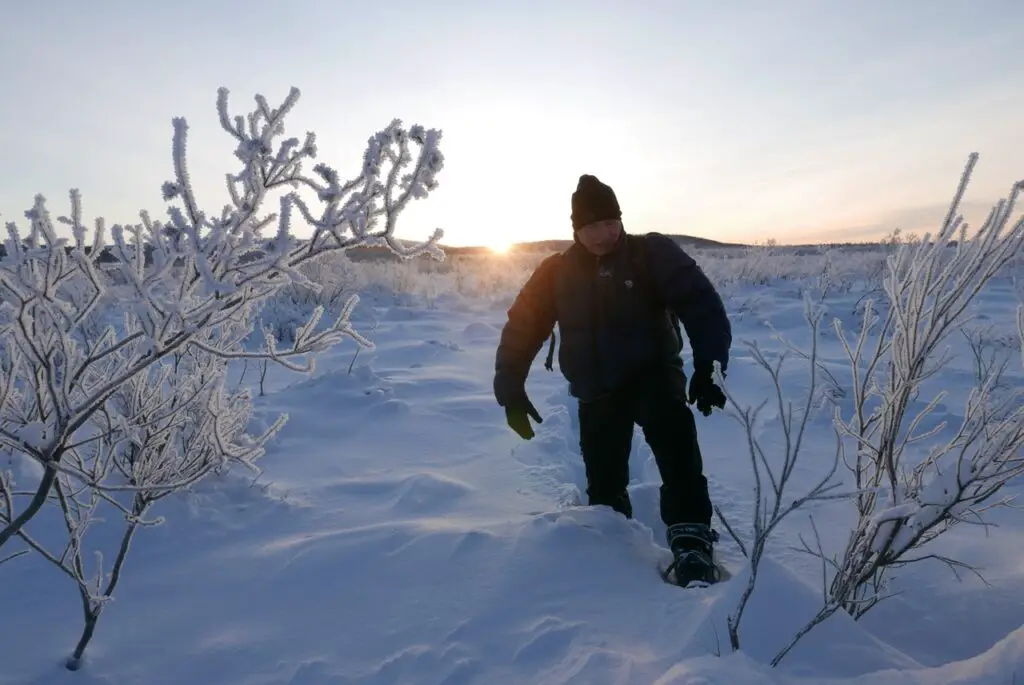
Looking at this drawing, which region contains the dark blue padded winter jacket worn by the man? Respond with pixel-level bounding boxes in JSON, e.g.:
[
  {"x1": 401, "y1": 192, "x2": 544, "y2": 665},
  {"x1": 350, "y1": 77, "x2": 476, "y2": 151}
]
[{"x1": 495, "y1": 231, "x2": 732, "y2": 405}]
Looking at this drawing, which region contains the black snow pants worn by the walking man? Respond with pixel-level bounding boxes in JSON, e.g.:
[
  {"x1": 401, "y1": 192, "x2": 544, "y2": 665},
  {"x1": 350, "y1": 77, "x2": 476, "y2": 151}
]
[{"x1": 580, "y1": 367, "x2": 712, "y2": 526}]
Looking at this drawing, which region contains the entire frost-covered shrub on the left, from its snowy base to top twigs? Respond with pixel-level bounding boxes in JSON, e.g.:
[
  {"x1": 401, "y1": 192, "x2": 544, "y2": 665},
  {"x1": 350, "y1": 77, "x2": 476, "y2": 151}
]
[{"x1": 0, "y1": 82, "x2": 443, "y2": 667}]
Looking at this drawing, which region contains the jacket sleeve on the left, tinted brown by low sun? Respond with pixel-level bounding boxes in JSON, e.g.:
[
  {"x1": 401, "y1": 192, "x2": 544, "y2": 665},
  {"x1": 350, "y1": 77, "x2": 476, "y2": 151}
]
[{"x1": 495, "y1": 255, "x2": 561, "y2": 406}]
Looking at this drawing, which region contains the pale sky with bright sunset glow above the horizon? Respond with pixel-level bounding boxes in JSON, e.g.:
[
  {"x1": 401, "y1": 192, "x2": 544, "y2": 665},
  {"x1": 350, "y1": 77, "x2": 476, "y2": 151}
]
[{"x1": 0, "y1": 0, "x2": 1024, "y2": 246}]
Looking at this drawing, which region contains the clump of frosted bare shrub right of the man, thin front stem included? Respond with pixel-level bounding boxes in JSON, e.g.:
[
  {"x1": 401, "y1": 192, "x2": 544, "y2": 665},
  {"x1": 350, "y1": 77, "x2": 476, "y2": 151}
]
[{"x1": 720, "y1": 155, "x2": 1024, "y2": 665}]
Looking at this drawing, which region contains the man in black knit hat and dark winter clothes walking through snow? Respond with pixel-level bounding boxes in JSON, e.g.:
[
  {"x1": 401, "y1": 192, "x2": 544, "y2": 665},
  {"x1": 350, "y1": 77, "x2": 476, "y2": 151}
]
[{"x1": 494, "y1": 174, "x2": 732, "y2": 587}]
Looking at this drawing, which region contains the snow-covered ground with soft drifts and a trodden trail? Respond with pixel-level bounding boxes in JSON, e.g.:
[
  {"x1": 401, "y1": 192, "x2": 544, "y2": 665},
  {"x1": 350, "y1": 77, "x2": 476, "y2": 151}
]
[{"x1": 0, "y1": 246, "x2": 1024, "y2": 685}]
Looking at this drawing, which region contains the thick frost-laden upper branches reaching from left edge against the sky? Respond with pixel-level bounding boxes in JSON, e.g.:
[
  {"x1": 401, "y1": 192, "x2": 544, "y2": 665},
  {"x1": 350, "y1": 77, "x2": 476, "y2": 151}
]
[{"x1": 0, "y1": 83, "x2": 443, "y2": 549}]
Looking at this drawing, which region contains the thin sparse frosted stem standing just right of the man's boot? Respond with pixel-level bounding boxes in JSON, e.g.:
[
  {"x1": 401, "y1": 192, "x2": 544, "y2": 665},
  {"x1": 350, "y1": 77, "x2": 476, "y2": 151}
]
[{"x1": 715, "y1": 299, "x2": 849, "y2": 658}]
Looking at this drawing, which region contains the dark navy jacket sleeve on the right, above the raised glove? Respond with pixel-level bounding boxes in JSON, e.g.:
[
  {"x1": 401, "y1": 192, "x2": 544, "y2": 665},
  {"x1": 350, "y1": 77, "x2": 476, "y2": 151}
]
[{"x1": 646, "y1": 233, "x2": 732, "y2": 371}]
